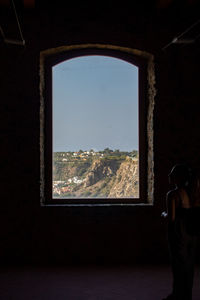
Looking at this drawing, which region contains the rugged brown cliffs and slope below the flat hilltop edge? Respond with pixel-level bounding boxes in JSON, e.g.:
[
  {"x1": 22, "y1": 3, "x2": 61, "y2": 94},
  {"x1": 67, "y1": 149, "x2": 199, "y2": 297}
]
[{"x1": 54, "y1": 156, "x2": 139, "y2": 198}]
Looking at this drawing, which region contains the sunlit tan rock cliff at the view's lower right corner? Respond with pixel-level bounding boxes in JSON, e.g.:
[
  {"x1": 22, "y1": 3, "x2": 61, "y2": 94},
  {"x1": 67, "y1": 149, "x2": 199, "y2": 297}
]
[{"x1": 108, "y1": 158, "x2": 139, "y2": 198}]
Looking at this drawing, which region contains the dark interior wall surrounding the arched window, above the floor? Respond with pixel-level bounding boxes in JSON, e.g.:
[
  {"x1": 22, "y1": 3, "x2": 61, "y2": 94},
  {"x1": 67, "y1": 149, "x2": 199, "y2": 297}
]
[{"x1": 0, "y1": 2, "x2": 200, "y2": 263}]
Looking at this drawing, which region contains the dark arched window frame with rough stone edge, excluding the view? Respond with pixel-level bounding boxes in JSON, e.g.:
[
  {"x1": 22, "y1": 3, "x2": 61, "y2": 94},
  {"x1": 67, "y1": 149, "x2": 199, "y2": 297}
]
[{"x1": 40, "y1": 44, "x2": 155, "y2": 205}]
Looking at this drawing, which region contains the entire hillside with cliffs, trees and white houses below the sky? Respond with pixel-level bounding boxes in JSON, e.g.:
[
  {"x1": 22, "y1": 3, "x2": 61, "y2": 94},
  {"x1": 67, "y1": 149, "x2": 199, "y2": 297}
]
[{"x1": 53, "y1": 148, "x2": 139, "y2": 198}]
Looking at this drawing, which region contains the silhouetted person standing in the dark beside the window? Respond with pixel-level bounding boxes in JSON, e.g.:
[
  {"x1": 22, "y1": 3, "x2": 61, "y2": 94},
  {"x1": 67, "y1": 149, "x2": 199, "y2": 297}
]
[{"x1": 162, "y1": 164, "x2": 195, "y2": 300}]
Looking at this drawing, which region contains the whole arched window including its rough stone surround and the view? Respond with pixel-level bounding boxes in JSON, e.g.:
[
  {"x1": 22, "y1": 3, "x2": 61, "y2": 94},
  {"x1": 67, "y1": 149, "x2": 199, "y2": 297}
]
[{"x1": 40, "y1": 45, "x2": 155, "y2": 204}]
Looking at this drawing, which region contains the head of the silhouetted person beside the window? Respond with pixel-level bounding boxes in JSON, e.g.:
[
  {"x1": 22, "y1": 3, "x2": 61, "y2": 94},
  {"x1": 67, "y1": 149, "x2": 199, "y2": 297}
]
[{"x1": 169, "y1": 164, "x2": 191, "y2": 187}]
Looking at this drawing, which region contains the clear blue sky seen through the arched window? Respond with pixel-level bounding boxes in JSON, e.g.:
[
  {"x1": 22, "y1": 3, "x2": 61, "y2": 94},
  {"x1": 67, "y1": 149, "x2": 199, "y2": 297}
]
[{"x1": 53, "y1": 56, "x2": 138, "y2": 152}]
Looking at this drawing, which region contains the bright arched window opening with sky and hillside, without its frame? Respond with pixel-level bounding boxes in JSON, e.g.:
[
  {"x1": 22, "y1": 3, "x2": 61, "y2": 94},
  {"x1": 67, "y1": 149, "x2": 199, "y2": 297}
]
[{"x1": 52, "y1": 55, "x2": 139, "y2": 199}]
